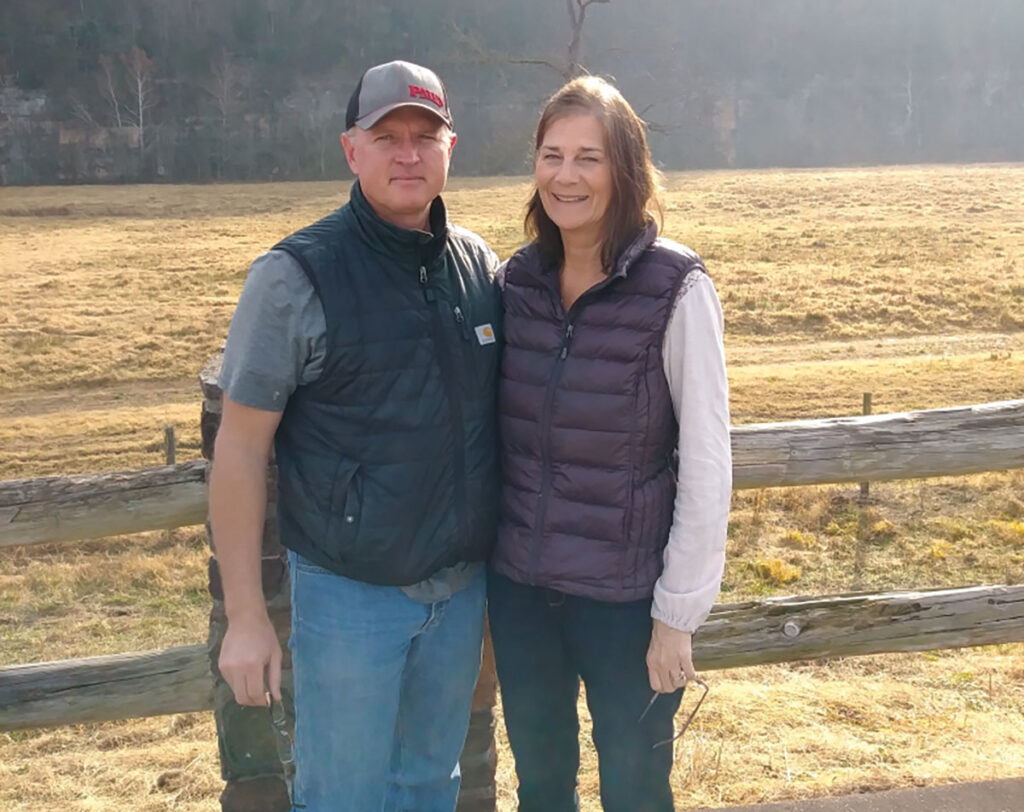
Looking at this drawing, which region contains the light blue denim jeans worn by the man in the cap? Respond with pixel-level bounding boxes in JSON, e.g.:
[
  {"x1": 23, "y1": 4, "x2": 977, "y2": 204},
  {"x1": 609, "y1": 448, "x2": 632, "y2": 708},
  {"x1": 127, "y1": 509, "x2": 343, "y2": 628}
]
[{"x1": 289, "y1": 553, "x2": 486, "y2": 812}]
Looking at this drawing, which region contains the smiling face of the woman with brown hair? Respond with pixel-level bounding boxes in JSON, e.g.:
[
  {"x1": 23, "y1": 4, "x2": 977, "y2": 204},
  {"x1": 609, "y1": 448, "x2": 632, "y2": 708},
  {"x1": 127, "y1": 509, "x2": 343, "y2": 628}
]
[{"x1": 534, "y1": 113, "x2": 612, "y2": 241}]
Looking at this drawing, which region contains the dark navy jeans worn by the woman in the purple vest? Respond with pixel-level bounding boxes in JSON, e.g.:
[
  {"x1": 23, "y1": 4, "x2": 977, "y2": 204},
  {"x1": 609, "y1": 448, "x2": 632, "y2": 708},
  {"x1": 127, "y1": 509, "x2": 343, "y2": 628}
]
[{"x1": 487, "y1": 572, "x2": 682, "y2": 812}]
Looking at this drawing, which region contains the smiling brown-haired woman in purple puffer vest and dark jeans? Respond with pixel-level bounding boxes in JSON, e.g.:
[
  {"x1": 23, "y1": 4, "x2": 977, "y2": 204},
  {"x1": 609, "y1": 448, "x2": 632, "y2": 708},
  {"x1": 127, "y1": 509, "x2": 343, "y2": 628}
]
[{"x1": 488, "y1": 77, "x2": 731, "y2": 812}]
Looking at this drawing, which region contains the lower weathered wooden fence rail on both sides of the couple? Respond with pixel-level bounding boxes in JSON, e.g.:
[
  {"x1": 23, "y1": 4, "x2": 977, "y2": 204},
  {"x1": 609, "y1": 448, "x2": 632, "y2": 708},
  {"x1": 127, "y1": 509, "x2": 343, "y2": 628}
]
[{"x1": 0, "y1": 586, "x2": 1024, "y2": 731}]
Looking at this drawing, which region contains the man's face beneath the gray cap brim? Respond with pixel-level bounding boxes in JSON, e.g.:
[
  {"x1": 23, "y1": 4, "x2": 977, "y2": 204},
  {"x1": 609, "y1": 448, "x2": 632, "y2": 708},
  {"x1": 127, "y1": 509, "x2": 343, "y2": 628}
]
[{"x1": 341, "y1": 106, "x2": 456, "y2": 228}]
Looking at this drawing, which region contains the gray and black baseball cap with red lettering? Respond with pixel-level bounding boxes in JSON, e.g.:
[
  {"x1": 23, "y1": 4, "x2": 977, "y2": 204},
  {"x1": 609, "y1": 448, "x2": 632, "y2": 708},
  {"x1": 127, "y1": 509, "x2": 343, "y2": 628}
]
[{"x1": 345, "y1": 59, "x2": 452, "y2": 130}]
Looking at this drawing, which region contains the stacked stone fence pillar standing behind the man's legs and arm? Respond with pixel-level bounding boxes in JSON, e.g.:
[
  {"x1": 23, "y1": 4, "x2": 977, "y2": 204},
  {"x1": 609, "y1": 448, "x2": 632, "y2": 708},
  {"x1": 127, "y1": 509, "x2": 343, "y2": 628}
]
[{"x1": 200, "y1": 354, "x2": 498, "y2": 812}]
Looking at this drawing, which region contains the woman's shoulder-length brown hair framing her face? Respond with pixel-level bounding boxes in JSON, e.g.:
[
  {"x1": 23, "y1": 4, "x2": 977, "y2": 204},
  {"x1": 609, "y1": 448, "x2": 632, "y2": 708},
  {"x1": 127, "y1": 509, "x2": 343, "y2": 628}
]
[{"x1": 523, "y1": 76, "x2": 658, "y2": 273}]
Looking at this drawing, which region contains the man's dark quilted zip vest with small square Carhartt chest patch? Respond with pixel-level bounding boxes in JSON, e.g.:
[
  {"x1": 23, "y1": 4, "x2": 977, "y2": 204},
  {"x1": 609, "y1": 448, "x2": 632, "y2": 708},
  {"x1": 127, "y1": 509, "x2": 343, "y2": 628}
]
[{"x1": 274, "y1": 182, "x2": 501, "y2": 586}]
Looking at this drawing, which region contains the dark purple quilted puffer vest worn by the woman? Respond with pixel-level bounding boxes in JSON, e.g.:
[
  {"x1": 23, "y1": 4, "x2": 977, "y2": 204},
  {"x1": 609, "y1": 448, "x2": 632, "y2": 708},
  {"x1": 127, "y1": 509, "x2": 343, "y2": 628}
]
[{"x1": 492, "y1": 223, "x2": 703, "y2": 602}]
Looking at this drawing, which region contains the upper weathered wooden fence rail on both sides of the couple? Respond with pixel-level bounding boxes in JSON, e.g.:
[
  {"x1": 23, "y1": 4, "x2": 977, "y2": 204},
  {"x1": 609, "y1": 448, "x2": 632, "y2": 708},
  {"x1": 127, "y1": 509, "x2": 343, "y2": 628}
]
[{"x1": 0, "y1": 400, "x2": 1024, "y2": 547}]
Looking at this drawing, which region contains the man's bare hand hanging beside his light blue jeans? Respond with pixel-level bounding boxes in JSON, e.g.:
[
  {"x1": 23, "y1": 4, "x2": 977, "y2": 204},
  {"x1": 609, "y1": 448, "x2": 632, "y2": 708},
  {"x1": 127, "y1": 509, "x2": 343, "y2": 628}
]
[{"x1": 217, "y1": 611, "x2": 281, "y2": 706}]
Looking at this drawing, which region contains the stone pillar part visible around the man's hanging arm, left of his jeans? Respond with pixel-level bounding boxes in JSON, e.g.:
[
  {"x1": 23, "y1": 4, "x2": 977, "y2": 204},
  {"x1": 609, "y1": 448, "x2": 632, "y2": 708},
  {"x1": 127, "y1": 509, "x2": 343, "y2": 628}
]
[{"x1": 200, "y1": 355, "x2": 295, "y2": 812}]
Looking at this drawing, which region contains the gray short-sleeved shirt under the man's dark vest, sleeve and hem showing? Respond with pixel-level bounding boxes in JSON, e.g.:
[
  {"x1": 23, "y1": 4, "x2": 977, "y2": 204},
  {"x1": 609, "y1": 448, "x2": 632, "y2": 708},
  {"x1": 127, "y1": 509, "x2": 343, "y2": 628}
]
[{"x1": 218, "y1": 251, "x2": 481, "y2": 603}]
